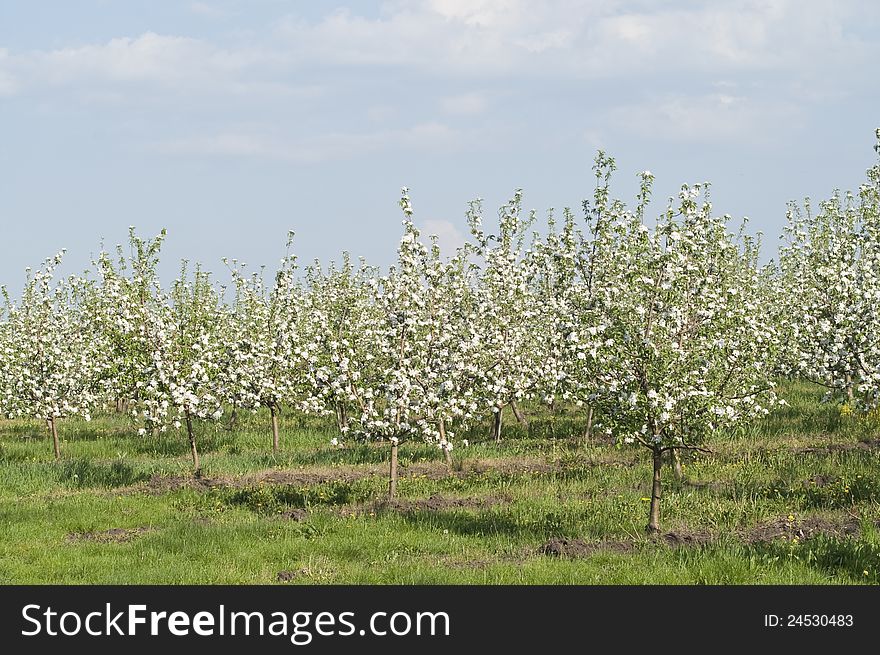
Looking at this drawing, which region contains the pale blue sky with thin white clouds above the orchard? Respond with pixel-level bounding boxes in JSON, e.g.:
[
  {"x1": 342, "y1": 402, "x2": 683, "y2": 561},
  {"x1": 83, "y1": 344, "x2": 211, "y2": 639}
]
[{"x1": 0, "y1": 0, "x2": 880, "y2": 292}]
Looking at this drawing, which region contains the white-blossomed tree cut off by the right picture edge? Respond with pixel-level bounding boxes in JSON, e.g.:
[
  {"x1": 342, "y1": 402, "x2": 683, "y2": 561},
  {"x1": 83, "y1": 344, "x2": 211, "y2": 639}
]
[{"x1": 780, "y1": 130, "x2": 880, "y2": 410}]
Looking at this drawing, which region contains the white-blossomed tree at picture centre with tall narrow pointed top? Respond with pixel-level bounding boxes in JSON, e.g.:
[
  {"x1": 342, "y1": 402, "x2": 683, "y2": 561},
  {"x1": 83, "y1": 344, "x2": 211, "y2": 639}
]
[{"x1": 370, "y1": 187, "x2": 482, "y2": 498}]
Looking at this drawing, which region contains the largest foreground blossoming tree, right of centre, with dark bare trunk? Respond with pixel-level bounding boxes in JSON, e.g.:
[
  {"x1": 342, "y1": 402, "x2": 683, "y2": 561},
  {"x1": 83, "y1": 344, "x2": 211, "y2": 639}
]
[{"x1": 596, "y1": 172, "x2": 779, "y2": 533}]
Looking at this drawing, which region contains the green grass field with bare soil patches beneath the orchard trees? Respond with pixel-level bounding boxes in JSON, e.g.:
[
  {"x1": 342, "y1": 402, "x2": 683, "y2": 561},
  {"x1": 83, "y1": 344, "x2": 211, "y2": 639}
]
[{"x1": 0, "y1": 383, "x2": 880, "y2": 584}]
